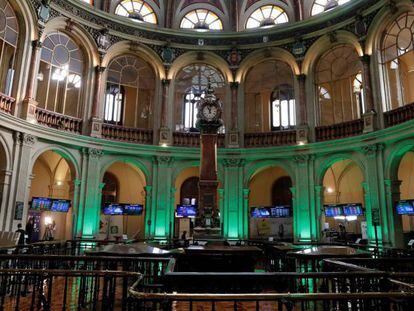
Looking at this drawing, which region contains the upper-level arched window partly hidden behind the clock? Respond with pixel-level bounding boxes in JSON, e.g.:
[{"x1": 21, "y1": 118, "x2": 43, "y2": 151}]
[{"x1": 176, "y1": 64, "x2": 225, "y2": 132}]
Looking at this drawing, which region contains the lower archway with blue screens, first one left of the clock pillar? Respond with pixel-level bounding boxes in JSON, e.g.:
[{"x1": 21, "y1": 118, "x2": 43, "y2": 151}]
[{"x1": 99, "y1": 161, "x2": 146, "y2": 239}]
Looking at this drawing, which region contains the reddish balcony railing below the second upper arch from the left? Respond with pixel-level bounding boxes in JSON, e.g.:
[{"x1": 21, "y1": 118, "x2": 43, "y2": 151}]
[{"x1": 36, "y1": 107, "x2": 82, "y2": 134}]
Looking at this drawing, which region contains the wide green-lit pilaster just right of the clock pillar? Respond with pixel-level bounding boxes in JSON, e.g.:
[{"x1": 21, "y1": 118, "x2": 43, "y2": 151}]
[{"x1": 222, "y1": 159, "x2": 248, "y2": 239}]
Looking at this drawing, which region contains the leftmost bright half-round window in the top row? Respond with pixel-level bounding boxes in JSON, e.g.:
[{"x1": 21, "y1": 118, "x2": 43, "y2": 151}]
[{"x1": 115, "y1": 0, "x2": 157, "y2": 24}]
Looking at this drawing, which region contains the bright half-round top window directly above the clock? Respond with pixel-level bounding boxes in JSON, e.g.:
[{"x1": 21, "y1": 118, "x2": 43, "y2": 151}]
[{"x1": 180, "y1": 9, "x2": 223, "y2": 31}]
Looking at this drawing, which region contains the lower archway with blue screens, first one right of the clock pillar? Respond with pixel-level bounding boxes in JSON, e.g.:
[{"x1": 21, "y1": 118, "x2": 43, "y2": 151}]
[{"x1": 249, "y1": 167, "x2": 293, "y2": 241}]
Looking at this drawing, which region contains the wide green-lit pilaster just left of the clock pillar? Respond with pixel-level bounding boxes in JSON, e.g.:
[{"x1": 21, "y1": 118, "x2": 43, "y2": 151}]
[{"x1": 150, "y1": 156, "x2": 174, "y2": 239}]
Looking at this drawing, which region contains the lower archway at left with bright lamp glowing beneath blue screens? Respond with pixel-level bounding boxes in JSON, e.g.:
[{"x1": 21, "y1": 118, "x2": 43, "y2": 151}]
[{"x1": 28, "y1": 151, "x2": 76, "y2": 242}]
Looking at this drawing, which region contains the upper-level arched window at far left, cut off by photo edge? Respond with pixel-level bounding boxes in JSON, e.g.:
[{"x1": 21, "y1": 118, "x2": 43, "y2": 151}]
[{"x1": 0, "y1": 0, "x2": 19, "y2": 96}]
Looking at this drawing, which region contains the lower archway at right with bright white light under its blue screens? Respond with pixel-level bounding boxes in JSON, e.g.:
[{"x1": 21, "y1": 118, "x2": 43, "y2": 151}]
[{"x1": 321, "y1": 159, "x2": 367, "y2": 242}]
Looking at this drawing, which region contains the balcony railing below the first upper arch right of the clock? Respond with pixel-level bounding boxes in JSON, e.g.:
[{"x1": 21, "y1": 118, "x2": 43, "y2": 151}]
[{"x1": 244, "y1": 131, "x2": 296, "y2": 148}]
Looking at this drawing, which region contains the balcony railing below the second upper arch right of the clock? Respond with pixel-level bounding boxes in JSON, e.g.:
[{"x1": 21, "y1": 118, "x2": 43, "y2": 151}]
[{"x1": 315, "y1": 119, "x2": 364, "y2": 141}]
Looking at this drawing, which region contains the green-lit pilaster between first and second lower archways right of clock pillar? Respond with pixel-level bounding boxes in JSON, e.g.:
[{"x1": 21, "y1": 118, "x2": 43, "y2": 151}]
[{"x1": 292, "y1": 155, "x2": 315, "y2": 242}]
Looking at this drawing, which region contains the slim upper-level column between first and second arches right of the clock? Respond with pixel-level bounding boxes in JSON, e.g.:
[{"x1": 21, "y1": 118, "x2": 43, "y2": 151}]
[{"x1": 296, "y1": 74, "x2": 309, "y2": 144}]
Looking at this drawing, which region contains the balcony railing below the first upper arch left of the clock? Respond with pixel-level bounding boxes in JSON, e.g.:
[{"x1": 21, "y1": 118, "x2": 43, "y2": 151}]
[{"x1": 102, "y1": 123, "x2": 153, "y2": 145}]
